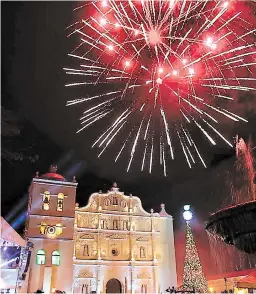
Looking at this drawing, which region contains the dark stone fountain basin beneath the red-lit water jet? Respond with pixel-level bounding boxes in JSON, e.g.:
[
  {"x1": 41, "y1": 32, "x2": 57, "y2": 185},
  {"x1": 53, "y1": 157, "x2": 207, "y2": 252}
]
[{"x1": 205, "y1": 200, "x2": 256, "y2": 254}]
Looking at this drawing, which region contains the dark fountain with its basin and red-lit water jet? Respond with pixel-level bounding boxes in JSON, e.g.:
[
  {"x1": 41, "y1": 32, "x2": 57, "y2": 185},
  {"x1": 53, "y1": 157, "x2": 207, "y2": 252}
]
[{"x1": 206, "y1": 138, "x2": 256, "y2": 254}]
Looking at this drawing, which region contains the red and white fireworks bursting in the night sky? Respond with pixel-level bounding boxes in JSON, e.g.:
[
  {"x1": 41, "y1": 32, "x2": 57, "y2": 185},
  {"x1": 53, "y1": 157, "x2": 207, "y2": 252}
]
[{"x1": 64, "y1": 0, "x2": 256, "y2": 175}]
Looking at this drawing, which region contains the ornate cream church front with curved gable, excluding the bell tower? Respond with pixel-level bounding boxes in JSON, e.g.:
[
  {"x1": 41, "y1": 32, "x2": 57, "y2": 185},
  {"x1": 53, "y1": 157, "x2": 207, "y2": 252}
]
[{"x1": 74, "y1": 189, "x2": 177, "y2": 293}]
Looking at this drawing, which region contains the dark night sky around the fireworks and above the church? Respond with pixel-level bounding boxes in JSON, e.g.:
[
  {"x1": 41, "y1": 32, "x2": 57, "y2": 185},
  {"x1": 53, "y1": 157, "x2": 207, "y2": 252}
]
[{"x1": 1, "y1": 1, "x2": 256, "y2": 280}]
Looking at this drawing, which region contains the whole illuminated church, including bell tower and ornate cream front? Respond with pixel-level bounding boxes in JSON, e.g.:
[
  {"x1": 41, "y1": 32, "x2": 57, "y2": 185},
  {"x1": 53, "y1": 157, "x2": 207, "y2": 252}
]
[{"x1": 26, "y1": 169, "x2": 177, "y2": 293}]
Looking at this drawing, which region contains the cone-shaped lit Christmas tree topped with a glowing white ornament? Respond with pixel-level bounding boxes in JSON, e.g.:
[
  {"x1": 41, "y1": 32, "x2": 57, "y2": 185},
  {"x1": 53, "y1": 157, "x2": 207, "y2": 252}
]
[{"x1": 182, "y1": 205, "x2": 208, "y2": 293}]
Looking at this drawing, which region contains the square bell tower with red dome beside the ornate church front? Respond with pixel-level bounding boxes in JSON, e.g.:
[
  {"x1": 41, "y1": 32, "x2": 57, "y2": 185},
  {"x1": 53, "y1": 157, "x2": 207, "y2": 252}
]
[{"x1": 25, "y1": 165, "x2": 77, "y2": 293}]
